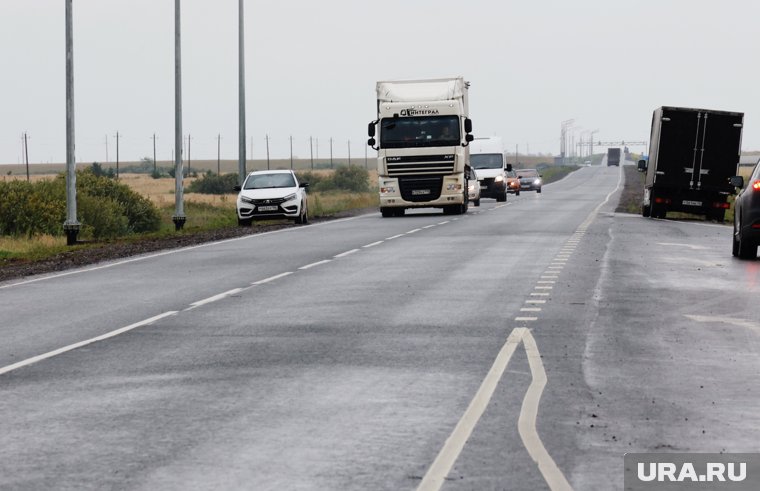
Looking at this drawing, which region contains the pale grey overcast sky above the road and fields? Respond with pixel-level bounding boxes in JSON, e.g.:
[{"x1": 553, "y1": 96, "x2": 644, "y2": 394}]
[{"x1": 0, "y1": 0, "x2": 760, "y2": 163}]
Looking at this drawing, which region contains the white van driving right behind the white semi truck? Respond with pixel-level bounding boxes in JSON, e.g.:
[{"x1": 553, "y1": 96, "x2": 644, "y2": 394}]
[{"x1": 470, "y1": 136, "x2": 512, "y2": 201}]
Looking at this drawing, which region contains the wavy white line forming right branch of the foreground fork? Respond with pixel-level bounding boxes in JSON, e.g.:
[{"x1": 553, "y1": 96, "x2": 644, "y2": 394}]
[{"x1": 517, "y1": 331, "x2": 573, "y2": 491}]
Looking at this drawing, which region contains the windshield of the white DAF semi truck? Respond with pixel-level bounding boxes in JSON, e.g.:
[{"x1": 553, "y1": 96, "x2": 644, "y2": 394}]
[{"x1": 380, "y1": 116, "x2": 462, "y2": 148}]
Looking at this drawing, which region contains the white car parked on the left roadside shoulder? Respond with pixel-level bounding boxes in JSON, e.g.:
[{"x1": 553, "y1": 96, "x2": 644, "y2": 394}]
[{"x1": 235, "y1": 170, "x2": 309, "y2": 226}]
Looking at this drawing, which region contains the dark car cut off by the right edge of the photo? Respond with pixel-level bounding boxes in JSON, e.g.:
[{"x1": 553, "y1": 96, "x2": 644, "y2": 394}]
[{"x1": 731, "y1": 162, "x2": 760, "y2": 259}]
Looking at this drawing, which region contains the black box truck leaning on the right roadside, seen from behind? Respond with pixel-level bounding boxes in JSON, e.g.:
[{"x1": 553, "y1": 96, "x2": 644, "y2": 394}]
[{"x1": 638, "y1": 106, "x2": 744, "y2": 222}]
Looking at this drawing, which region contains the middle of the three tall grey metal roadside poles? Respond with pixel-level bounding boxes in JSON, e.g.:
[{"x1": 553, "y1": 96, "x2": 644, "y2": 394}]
[{"x1": 172, "y1": 0, "x2": 187, "y2": 231}]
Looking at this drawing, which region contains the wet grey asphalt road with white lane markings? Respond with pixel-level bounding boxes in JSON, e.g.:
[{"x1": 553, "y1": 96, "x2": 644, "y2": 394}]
[{"x1": 0, "y1": 166, "x2": 760, "y2": 490}]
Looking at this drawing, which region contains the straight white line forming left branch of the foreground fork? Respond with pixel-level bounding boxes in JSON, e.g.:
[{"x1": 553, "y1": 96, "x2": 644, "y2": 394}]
[{"x1": 417, "y1": 327, "x2": 527, "y2": 491}]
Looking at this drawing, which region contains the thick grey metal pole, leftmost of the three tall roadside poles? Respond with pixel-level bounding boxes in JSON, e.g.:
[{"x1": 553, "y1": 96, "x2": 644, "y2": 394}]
[{"x1": 63, "y1": 0, "x2": 80, "y2": 246}]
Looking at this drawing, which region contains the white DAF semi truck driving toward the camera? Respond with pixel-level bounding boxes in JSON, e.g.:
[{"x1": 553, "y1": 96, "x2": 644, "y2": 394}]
[{"x1": 367, "y1": 77, "x2": 474, "y2": 217}]
